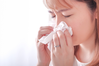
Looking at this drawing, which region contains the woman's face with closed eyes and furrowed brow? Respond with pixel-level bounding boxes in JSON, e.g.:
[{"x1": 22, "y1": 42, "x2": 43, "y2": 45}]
[{"x1": 49, "y1": 0, "x2": 95, "y2": 45}]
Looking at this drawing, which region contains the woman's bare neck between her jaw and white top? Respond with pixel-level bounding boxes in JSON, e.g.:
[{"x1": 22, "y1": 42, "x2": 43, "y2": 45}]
[{"x1": 76, "y1": 33, "x2": 95, "y2": 63}]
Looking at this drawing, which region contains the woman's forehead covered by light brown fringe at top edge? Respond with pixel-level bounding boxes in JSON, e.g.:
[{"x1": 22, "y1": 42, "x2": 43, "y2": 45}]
[{"x1": 44, "y1": 0, "x2": 73, "y2": 10}]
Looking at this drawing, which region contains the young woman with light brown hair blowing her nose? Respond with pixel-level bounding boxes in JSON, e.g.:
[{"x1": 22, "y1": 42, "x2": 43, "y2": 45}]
[{"x1": 36, "y1": 0, "x2": 99, "y2": 66}]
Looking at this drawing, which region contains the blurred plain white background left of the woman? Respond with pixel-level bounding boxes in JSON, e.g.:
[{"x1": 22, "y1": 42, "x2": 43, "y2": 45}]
[{"x1": 0, "y1": 0, "x2": 48, "y2": 66}]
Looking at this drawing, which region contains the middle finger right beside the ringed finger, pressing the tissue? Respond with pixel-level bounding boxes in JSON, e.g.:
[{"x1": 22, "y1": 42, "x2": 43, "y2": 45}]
[{"x1": 57, "y1": 31, "x2": 67, "y2": 49}]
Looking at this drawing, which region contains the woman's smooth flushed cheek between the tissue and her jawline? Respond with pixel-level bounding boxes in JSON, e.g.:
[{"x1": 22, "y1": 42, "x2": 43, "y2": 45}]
[{"x1": 71, "y1": 17, "x2": 94, "y2": 45}]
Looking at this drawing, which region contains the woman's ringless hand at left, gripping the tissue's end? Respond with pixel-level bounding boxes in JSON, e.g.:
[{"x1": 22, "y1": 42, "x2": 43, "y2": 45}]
[{"x1": 36, "y1": 26, "x2": 53, "y2": 66}]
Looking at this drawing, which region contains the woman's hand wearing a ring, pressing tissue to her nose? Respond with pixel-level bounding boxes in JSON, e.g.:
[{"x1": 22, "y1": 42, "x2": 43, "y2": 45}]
[{"x1": 51, "y1": 30, "x2": 74, "y2": 66}]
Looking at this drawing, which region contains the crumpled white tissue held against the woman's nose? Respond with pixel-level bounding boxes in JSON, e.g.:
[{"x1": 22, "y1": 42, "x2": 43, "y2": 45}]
[{"x1": 39, "y1": 21, "x2": 73, "y2": 44}]
